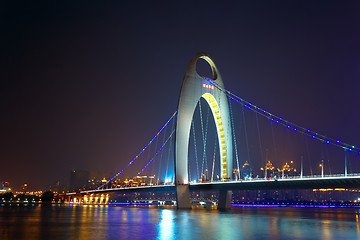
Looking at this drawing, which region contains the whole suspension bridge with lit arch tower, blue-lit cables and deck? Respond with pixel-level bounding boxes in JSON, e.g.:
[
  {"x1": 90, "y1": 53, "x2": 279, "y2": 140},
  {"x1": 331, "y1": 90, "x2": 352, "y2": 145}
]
[{"x1": 68, "y1": 53, "x2": 360, "y2": 209}]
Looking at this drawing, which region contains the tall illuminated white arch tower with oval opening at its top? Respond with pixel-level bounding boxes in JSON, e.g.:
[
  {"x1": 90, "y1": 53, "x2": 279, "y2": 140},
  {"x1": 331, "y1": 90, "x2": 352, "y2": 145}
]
[{"x1": 175, "y1": 53, "x2": 233, "y2": 186}]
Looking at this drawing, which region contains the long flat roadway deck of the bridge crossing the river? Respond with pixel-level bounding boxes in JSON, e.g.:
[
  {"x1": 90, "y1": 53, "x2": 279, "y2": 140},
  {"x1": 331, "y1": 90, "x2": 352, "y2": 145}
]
[{"x1": 76, "y1": 174, "x2": 360, "y2": 195}]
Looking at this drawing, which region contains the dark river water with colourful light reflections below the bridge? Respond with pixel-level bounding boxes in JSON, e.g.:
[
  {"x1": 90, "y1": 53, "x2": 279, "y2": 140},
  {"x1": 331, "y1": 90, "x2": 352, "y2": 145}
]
[{"x1": 0, "y1": 205, "x2": 360, "y2": 240}]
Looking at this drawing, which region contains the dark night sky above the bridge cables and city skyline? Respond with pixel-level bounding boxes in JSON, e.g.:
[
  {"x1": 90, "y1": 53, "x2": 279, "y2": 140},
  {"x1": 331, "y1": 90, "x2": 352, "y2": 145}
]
[{"x1": 0, "y1": 1, "x2": 360, "y2": 188}]
